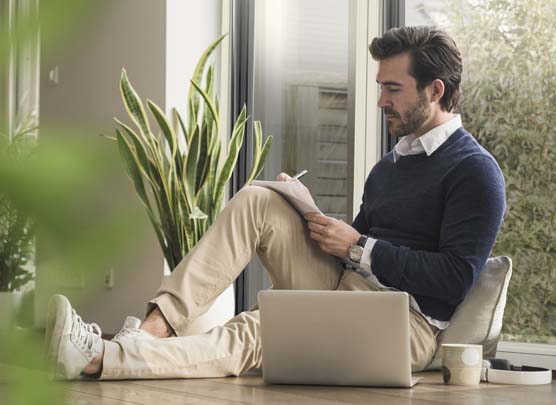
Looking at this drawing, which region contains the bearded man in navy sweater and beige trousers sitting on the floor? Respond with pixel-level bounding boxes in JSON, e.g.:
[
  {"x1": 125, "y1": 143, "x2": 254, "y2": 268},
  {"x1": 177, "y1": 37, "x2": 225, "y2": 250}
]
[{"x1": 47, "y1": 27, "x2": 505, "y2": 379}]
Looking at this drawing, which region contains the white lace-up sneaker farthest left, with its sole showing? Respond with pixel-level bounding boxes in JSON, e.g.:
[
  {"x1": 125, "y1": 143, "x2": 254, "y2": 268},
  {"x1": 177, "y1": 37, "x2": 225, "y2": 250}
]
[{"x1": 46, "y1": 295, "x2": 104, "y2": 379}]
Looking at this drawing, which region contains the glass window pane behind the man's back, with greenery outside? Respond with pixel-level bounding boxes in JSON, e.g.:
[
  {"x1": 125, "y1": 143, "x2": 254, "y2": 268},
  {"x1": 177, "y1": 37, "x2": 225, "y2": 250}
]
[{"x1": 405, "y1": 0, "x2": 556, "y2": 343}]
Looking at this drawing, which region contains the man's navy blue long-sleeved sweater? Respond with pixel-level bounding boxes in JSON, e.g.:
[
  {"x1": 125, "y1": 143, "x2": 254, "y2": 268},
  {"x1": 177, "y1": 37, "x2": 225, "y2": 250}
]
[{"x1": 353, "y1": 128, "x2": 506, "y2": 321}]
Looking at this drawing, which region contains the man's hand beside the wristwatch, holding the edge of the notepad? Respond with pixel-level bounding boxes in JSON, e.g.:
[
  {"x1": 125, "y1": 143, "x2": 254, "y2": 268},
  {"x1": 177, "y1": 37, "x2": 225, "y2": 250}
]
[{"x1": 304, "y1": 212, "x2": 361, "y2": 257}]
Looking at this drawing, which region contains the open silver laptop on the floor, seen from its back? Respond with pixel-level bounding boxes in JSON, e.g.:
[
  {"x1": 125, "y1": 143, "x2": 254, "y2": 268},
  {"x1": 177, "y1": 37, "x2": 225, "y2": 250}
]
[{"x1": 258, "y1": 290, "x2": 419, "y2": 387}]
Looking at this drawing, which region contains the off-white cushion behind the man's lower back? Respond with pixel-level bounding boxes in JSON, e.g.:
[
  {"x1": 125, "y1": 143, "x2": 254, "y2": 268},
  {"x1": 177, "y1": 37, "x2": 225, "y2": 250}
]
[{"x1": 427, "y1": 256, "x2": 512, "y2": 370}]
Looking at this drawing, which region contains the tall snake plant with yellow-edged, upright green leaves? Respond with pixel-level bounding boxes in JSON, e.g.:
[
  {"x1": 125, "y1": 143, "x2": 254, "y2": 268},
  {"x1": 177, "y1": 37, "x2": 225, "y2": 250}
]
[{"x1": 115, "y1": 36, "x2": 272, "y2": 270}]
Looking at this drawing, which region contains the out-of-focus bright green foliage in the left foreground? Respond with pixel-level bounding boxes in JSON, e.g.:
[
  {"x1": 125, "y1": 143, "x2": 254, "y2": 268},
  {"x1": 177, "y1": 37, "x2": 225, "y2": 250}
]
[{"x1": 0, "y1": 0, "x2": 138, "y2": 405}]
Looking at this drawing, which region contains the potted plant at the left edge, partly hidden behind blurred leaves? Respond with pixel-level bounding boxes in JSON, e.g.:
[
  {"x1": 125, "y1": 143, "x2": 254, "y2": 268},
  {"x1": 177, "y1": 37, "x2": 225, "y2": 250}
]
[{"x1": 0, "y1": 120, "x2": 35, "y2": 329}]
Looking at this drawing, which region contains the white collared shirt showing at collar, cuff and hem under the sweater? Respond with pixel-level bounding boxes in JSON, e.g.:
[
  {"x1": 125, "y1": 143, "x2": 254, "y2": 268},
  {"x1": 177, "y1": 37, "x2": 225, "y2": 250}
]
[{"x1": 352, "y1": 114, "x2": 462, "y2": 330}]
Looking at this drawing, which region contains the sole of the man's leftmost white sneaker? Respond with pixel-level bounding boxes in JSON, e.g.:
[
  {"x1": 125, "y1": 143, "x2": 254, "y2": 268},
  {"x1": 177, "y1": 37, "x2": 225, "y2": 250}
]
[{"x1": 46, "y1": 295, "x2": 71, "y2": 379}]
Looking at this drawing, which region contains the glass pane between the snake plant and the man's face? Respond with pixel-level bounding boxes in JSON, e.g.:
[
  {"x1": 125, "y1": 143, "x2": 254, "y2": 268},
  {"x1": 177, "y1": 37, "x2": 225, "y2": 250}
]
[{"x1": 250, "y1": 0, "x2": 352, "y2": 302}]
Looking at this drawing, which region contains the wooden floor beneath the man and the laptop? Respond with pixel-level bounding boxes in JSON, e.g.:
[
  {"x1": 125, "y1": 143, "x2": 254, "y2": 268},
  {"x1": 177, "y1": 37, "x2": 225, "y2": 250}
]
[{"x1": 0, "y1": 370, "x2": 556, "y2": 405}]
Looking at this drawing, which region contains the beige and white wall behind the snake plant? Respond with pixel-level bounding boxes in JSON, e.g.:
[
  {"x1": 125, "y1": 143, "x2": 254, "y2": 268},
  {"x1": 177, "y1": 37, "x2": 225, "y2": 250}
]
[{"x1": 35, "y1": 0, "x2": 221, "y2": 333}]
